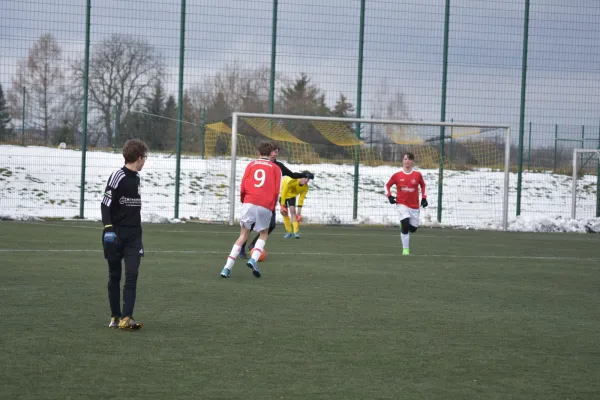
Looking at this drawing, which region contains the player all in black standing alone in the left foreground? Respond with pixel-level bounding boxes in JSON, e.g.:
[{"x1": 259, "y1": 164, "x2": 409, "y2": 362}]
[{"x1": 100, "y1": 139, "x2": 148, "y2": 329}]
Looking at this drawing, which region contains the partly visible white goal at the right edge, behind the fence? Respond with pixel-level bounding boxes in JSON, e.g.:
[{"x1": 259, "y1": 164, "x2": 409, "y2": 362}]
[{"x1": 571, "y1": 149, "x2": 600, "y2": 219}]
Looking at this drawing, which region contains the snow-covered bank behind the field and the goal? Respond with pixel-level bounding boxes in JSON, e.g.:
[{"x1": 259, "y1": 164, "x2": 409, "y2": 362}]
[{"x1": 0, "y1": 146, "x2": 600, "y2": 232}]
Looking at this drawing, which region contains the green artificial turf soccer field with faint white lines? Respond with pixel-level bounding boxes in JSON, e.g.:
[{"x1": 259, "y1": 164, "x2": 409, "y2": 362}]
[{"x1": 0, "y1": 221, "x2": 600, "y2": 400}]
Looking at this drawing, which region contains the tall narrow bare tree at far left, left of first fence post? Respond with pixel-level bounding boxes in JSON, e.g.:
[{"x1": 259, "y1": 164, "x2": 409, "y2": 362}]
[{"x1": 8, "y1": 33, "x2": 64, "y2": 143}]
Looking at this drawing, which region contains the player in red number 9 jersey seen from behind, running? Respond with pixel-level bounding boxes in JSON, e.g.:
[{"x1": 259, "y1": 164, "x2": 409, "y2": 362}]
[{"x1": 221, "y1": 142, "x2": 281, "y2": 278}]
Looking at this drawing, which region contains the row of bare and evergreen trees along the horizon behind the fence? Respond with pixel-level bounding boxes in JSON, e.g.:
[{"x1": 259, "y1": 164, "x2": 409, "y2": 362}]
[{"x1": 0, "y1": 33, "x2": 408, "y2": 153}]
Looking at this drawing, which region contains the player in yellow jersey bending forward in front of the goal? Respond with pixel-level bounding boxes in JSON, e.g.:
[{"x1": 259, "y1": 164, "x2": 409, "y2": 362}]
[{"x1": 279, "y1": 171, "x2": 314, "y2": 239}]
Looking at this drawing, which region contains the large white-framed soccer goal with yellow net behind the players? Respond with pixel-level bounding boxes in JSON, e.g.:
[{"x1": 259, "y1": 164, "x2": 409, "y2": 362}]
[{"x1": 226, "y1": 112, "x2": 510, "y2": 230}]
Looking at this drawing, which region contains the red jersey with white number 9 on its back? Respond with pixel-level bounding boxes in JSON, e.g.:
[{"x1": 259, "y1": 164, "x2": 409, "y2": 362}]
[{"x1": 240, "y1": 158, "x2": 281, "y2": 210}]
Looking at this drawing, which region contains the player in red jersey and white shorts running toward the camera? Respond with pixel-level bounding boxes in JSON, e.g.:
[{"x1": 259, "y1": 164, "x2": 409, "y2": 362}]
[{"x1": 385, "y1": 153, "x2": 428, "y2": 256}]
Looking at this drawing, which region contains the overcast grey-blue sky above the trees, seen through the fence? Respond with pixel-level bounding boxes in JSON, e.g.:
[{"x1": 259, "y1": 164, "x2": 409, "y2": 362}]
[{"x1": 0, "y1": 0, "x2": 600, "y2": 147}]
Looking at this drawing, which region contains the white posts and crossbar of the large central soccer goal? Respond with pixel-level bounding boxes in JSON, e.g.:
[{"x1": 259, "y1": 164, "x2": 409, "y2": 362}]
[{"x1": 229, "y1": 112, "x2": 510, "y2": 231}]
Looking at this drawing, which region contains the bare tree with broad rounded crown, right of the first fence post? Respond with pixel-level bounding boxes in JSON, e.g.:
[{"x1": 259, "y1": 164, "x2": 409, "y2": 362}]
[{"x1": 74, "y1": 34, "x2": 165, "y2": 144}]
